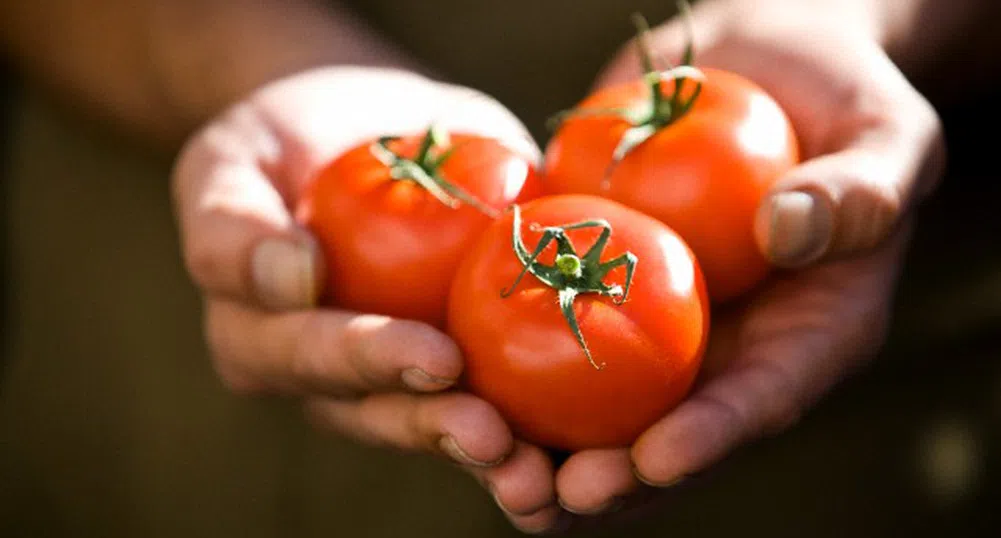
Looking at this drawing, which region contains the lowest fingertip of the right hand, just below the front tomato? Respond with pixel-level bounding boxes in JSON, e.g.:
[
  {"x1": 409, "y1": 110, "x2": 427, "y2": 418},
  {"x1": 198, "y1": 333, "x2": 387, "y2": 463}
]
[{"x1": 556, "y1": 449, "x2": 640, "y2": 516}]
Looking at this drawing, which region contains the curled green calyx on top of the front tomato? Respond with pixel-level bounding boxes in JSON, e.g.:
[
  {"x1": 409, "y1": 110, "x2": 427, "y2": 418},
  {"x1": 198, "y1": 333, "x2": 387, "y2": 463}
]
[{"x1": 501, "y1": 205, "x2": 639, "y2": 370}]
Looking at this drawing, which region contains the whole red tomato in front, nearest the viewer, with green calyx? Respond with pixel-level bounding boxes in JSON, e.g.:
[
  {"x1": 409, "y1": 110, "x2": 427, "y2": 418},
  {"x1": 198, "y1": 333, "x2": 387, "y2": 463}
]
[{"x1": 448, "y1": 195, "x2": 710, "y2": 451}]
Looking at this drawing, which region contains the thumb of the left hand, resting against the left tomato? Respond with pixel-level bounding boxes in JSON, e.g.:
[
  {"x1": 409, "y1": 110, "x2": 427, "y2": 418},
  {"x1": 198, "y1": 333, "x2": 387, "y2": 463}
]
[{"x1": 173, "y1": 102, "x2": 322, "y2": 309}]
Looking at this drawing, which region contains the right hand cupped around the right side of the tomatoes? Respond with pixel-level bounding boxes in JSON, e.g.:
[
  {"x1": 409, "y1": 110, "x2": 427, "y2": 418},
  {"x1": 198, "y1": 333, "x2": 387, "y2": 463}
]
[{"x1": 540, "y1": 0, "x2": 944, "y2": 528}]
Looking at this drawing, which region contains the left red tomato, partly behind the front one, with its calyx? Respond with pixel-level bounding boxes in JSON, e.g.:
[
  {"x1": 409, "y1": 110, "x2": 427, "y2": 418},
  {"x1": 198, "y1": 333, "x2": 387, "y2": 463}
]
[{"x1": 296, "y1": 129, "x2": 541, "y2": 328}]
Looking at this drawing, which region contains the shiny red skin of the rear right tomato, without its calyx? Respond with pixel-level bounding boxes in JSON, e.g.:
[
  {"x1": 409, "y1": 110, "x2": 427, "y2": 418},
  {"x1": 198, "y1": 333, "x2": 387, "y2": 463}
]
[{"x1": 545, "y1": 68, "x2": 800, "y2": 303}]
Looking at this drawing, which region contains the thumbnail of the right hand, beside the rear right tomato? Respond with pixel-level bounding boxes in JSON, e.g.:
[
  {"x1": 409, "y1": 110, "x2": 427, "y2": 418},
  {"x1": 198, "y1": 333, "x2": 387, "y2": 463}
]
[{"x1": 755, "y1": 190, "x2": 834, "y2": 266}]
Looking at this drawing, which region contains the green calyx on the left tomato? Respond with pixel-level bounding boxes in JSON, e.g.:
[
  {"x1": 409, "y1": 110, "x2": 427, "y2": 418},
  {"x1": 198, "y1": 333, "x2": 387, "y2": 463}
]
[{"x1": 371, "y1": 125, "x2": 499, "y2": 218}]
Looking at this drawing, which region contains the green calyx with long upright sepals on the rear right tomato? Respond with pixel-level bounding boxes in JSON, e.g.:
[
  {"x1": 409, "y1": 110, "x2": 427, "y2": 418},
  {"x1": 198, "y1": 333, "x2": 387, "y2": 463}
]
[{"x1": 550, "y1": 0, "x2": 706, "y2": 188}]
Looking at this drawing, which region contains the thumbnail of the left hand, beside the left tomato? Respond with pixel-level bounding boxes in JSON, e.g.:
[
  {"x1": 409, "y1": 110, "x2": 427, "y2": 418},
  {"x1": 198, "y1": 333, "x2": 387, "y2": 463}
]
[{"x1": 251, "y1": 239, "x2": 317, "y2": 308}]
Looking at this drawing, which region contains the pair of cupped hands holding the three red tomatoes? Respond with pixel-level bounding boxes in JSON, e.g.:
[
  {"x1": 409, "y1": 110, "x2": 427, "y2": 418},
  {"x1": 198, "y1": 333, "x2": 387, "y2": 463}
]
[{"x1": 173, "y1": 1, "x2": 944, "y2": 532}]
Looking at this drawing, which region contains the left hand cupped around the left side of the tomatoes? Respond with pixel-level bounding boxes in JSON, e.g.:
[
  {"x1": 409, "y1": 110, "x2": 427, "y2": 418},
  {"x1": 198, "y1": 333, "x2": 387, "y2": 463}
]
[{"x1": 173, "y1": 68, "x2": 556, "y2": 525}]
